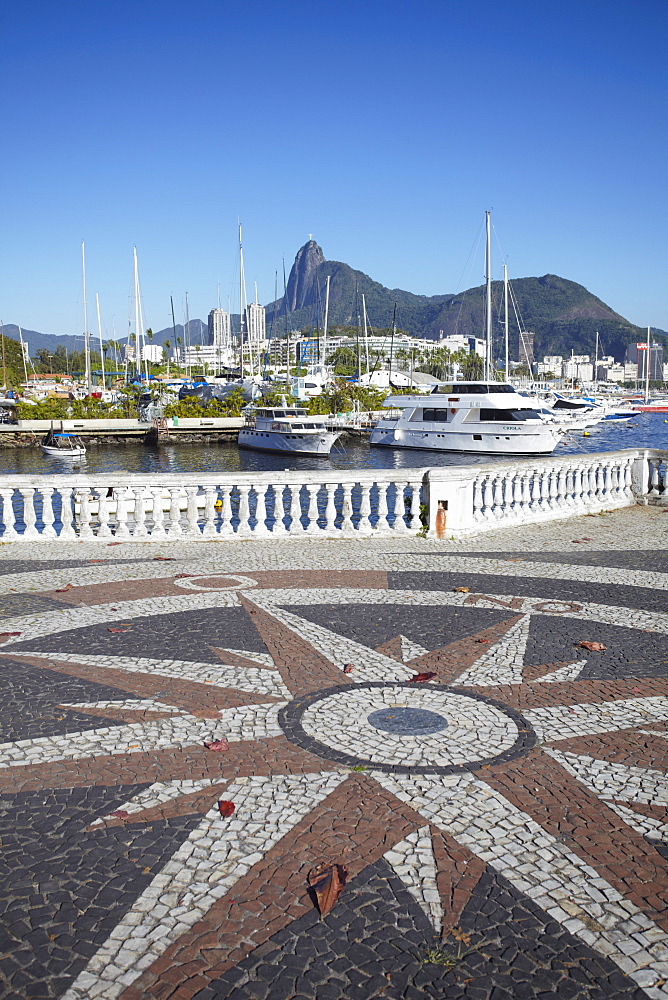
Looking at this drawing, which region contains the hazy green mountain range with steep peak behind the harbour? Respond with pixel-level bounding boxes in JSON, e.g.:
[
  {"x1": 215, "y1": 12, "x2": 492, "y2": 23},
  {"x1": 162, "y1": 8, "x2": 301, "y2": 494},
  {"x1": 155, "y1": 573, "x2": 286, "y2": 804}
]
[{"x1": 5, "y1": 240, "x2": 668, "y2": 361}]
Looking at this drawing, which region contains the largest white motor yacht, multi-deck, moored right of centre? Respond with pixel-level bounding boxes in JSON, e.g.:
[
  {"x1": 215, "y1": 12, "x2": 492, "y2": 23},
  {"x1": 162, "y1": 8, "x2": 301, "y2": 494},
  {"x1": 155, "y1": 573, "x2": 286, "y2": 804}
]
[{"x1": 370, "y1": 381, "x2": 564, "y2": 455}]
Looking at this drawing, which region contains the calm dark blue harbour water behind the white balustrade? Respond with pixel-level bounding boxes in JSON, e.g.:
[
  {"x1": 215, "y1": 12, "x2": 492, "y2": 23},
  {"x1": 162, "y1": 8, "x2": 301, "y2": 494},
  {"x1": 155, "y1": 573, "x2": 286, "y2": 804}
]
[{"x1": 0, "y1": 413, "x2": 668, "y2": 475}]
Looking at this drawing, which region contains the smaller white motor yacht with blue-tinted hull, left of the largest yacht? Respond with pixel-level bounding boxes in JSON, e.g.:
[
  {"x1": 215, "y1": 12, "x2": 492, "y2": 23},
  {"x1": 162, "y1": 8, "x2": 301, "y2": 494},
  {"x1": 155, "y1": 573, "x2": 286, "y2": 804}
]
[{"x1": 237, "y1": 406, "x2": 343, "y2": 455}]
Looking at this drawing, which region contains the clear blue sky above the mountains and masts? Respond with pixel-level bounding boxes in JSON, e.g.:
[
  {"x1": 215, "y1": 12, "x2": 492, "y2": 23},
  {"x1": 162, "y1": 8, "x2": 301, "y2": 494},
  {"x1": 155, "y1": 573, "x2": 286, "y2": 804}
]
[{"x1": 0, "y1": 0, "x2": 668, "y2": 336}]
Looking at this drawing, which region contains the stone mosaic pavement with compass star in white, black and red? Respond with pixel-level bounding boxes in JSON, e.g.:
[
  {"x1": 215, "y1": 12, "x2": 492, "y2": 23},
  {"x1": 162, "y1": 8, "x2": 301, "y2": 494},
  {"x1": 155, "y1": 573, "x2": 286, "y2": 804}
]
[{"x1": 0, "y1": 508, "x2": 668, "y2": 1000}]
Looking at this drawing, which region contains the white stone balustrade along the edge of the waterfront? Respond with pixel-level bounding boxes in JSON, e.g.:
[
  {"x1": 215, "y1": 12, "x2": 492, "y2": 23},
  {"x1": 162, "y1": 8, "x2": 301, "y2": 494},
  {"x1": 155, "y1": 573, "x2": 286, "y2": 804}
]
[{"x1": 0, "y1": 449, "x2": 668, "y2": 543}]
